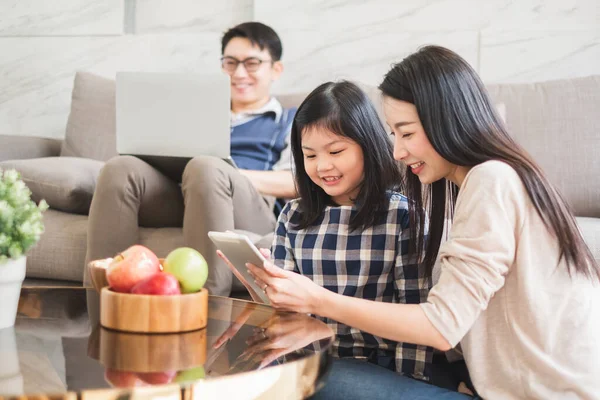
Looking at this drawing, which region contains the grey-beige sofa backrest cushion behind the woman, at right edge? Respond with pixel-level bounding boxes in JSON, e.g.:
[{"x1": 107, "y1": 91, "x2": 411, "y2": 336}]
[{"x1": 488, "y1": 76, "x2": 600, "y2": 217}]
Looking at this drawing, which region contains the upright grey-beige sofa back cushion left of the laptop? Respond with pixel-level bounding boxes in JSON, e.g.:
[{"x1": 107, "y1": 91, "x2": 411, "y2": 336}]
[{"x1": 60, "y1": 72, "x2": 117, "y2": 161}]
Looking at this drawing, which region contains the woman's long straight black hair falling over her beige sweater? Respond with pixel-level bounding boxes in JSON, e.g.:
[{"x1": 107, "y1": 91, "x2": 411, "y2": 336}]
[{"x1": 379, "y1": 46, "x2": 600, "y2": 279}]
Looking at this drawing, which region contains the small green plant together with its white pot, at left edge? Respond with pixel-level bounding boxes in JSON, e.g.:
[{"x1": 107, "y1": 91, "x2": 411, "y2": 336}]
[{"x1": 0, "y1": 169, "x2": 48, "y2": 329}]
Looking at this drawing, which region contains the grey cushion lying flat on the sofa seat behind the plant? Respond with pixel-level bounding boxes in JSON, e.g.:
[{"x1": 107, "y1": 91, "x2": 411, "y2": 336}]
[{"x1": 0, "y1": 157, "x2": 104, "y2": 215}]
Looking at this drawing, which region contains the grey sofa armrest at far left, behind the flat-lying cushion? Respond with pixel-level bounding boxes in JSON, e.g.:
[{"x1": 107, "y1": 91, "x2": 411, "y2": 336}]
[{"x1": 0, "y1": 135, "x2": 62, "y2": 161}]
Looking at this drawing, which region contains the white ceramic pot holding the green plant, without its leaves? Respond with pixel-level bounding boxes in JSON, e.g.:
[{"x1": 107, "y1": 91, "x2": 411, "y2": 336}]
[{"x1": 0, "y1": 256, "x2": 27, "y2": 329}]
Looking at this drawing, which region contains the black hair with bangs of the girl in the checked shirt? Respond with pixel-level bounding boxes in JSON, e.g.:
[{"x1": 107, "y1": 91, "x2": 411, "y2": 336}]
[{"x1": 291, "y1": 81, "x2": 401, "y2": 229}]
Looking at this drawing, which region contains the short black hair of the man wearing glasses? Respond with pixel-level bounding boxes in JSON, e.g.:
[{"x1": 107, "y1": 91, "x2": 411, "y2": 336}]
[{"x1": 221, "y1": 22, "x2": 283, "y2": 61}]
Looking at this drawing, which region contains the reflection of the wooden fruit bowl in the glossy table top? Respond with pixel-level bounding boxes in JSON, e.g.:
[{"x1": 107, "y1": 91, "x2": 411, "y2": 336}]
[{"x1": 88, "y1": 327, "x2": 206, "y2": 372}]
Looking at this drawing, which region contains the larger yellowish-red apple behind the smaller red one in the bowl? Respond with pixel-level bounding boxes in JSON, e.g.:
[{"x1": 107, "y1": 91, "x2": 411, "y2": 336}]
[{"x1": 106, "y1": 245, "x2": 160, "y2": 293}]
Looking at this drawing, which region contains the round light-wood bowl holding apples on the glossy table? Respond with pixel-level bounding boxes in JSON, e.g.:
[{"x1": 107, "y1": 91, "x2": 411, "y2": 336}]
[{"x1": 100, "y1": 287, "x2": 208, "y2": 333}]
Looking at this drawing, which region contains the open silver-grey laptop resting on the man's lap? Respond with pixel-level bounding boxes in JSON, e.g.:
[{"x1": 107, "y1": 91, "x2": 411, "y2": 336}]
[{"x1": 116, "y1": 71, "x2": 233, "y2": 181}]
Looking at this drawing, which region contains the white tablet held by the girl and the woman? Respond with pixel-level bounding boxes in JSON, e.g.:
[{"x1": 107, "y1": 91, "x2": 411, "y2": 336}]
[{"x1": 208, "y1": 231, "x2": 271, "y2": 304}]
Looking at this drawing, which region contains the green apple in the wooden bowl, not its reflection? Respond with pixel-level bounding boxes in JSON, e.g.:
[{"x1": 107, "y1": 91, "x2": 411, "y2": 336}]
[{"x1": 163, "y1": 247, "x2": 208, "y2": 293}]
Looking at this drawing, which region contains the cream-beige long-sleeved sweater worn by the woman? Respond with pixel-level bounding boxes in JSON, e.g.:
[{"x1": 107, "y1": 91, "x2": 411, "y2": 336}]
[{"x1": 421, "y1": 161, "x2": 600, "y2": 399}]
